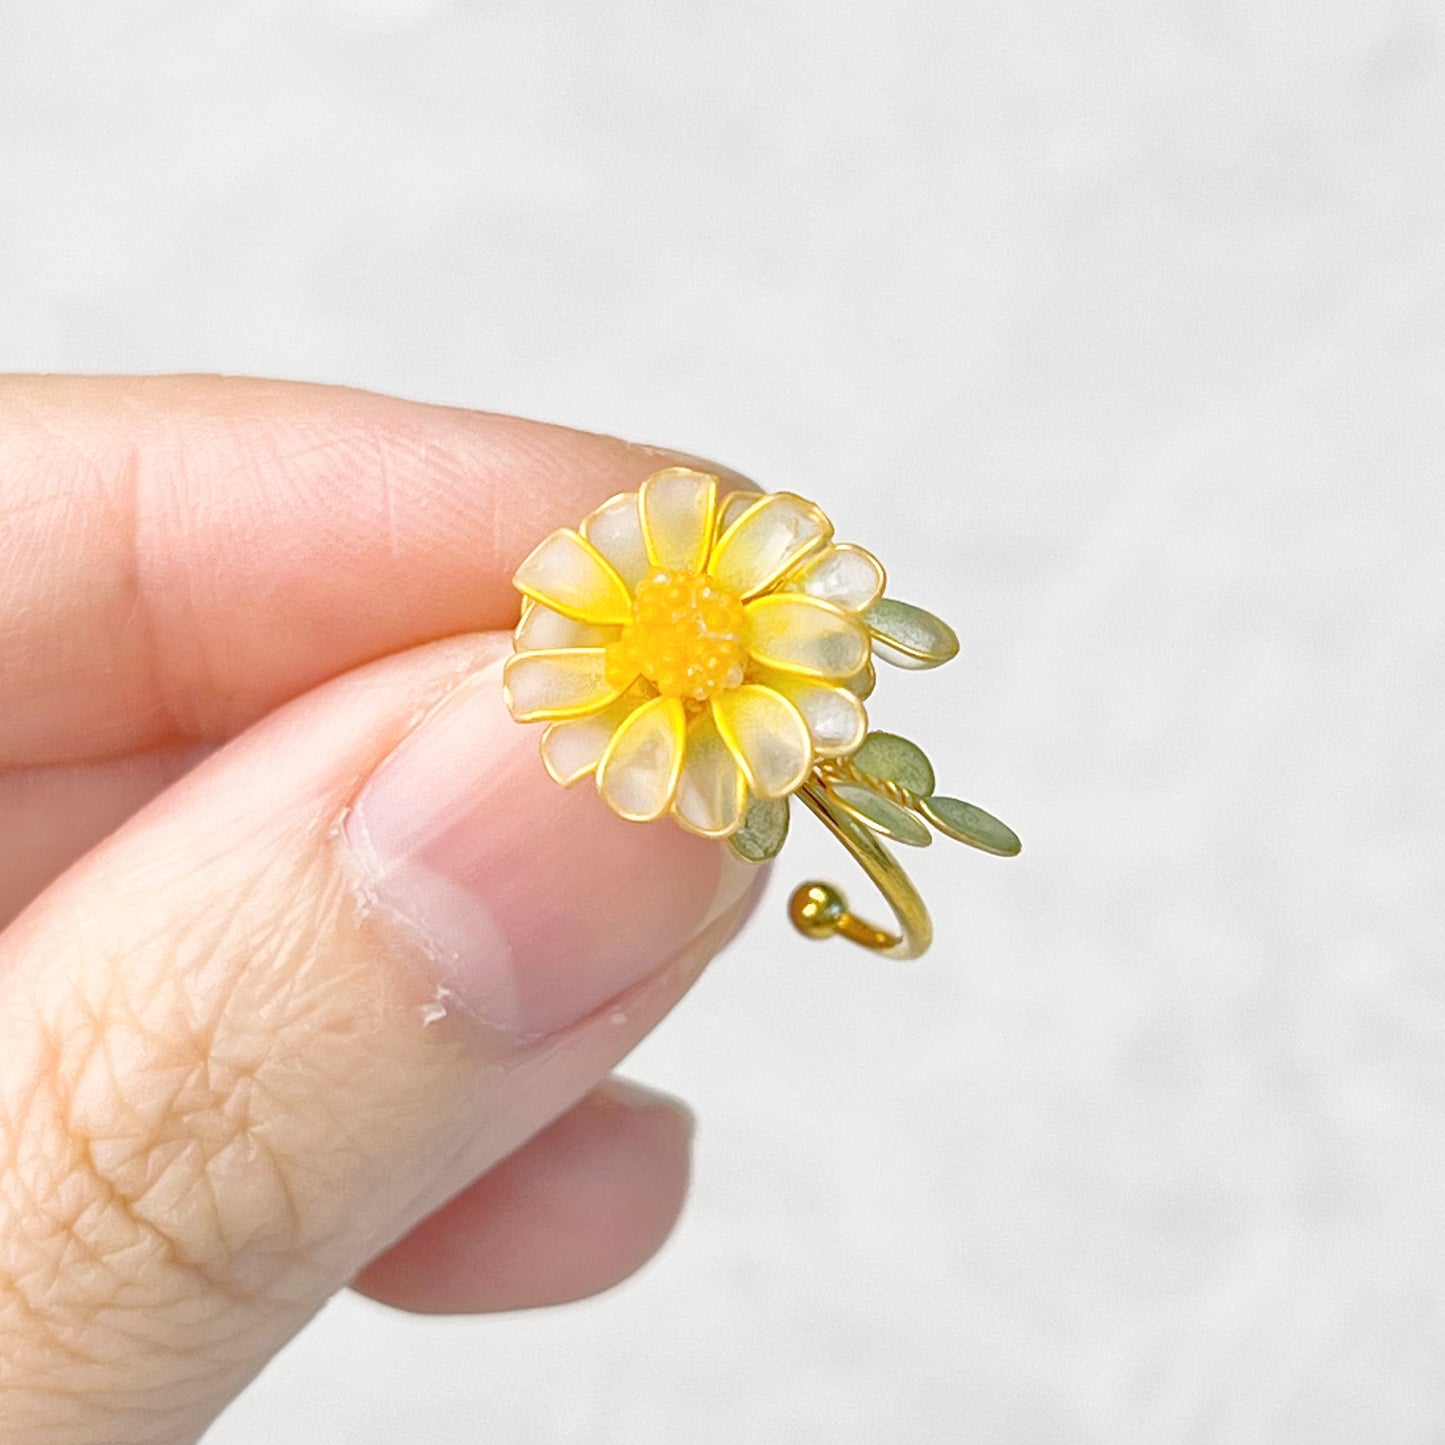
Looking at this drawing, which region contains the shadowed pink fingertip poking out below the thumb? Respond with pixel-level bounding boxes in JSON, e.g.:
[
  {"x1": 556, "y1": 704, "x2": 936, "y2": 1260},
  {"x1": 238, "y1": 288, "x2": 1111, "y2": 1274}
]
[{"x1": 351, "y1": 1079, "x2": 692, "y2": 1314}]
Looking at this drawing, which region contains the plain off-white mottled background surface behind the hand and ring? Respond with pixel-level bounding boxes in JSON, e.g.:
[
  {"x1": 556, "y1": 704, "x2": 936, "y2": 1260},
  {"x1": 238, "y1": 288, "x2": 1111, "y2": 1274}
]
[{"x1": 0, "y1": 0, "x2": 1445, "y2": 1445}]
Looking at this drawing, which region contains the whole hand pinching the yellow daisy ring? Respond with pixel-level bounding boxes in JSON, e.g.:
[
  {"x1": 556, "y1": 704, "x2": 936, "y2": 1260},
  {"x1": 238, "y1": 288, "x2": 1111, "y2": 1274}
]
[{"x1": 0, "y1": 379, "x2": 760, "y2": 1445}]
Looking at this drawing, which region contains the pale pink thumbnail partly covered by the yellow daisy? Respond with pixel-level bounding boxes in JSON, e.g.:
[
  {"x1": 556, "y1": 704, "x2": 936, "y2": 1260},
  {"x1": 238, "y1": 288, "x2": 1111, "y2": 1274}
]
[{"x1": 345, "y1": 663, "x2": 750, "y2": 1038}]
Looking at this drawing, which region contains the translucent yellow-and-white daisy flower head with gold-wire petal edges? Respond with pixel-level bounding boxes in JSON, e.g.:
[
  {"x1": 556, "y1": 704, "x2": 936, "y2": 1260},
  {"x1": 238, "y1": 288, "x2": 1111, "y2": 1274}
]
[{"x1": 504, "y1": 467, "x2": 890, "y2": 838}]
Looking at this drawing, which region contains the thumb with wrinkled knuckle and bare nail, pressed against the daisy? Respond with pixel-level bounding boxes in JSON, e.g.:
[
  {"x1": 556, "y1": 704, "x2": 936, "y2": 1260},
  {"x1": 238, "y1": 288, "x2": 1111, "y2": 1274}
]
[{"x1": 0, "y1": 636, "x2": 754, "y2": 1445}]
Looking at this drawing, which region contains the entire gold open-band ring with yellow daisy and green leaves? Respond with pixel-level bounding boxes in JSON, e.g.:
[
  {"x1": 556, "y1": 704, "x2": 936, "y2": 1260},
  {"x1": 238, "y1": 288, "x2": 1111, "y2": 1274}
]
[{"x1": 503, "y1": 467, "x2": 1020, "y2": 958}]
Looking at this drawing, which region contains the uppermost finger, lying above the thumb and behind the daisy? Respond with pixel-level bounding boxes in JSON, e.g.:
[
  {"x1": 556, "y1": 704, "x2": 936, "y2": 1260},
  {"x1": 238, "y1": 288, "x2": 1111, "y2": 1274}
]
[{"x1": 0, "y1": 377, "x2": 745, "y2": 767}]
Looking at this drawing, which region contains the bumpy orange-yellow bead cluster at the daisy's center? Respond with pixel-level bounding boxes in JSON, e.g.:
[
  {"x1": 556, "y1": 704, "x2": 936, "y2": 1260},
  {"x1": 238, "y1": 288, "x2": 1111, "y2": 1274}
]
[{"x1": 607, "y1": 568, "x2": 747, "y2": 702}]
